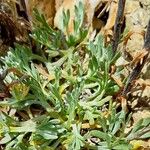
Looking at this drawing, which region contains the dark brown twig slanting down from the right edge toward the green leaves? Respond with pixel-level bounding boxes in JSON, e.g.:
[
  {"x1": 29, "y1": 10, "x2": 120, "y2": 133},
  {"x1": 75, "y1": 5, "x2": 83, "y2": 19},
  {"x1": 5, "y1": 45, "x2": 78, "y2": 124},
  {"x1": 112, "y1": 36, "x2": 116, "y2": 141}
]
[{"x1": 121, "y1": 20, "x2": 150, "y2": 96}]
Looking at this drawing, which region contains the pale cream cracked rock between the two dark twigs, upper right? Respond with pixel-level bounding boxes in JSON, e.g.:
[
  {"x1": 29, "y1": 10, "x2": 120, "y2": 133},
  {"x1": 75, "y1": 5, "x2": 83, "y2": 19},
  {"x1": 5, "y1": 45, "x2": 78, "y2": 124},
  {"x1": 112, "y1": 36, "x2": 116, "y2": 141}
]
[{"x1": 125, "y1": 0, "x2": 150, "y2": 53}]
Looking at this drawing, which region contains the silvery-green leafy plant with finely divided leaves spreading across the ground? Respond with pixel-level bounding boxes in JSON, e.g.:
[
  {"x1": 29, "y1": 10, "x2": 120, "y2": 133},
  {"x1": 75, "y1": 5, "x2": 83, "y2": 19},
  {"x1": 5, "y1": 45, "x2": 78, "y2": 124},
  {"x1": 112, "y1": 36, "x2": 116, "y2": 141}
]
[{"x1": 0, "y1": 3, "x2": 150, "y2": 150}]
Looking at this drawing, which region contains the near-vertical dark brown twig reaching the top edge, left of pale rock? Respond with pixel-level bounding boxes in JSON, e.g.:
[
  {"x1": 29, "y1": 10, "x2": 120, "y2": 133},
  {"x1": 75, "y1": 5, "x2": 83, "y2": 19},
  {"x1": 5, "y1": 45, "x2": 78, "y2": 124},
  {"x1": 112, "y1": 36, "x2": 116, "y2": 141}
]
[{"x1": 112, "y1": 0, "x2": 126, "y2": 54}]
